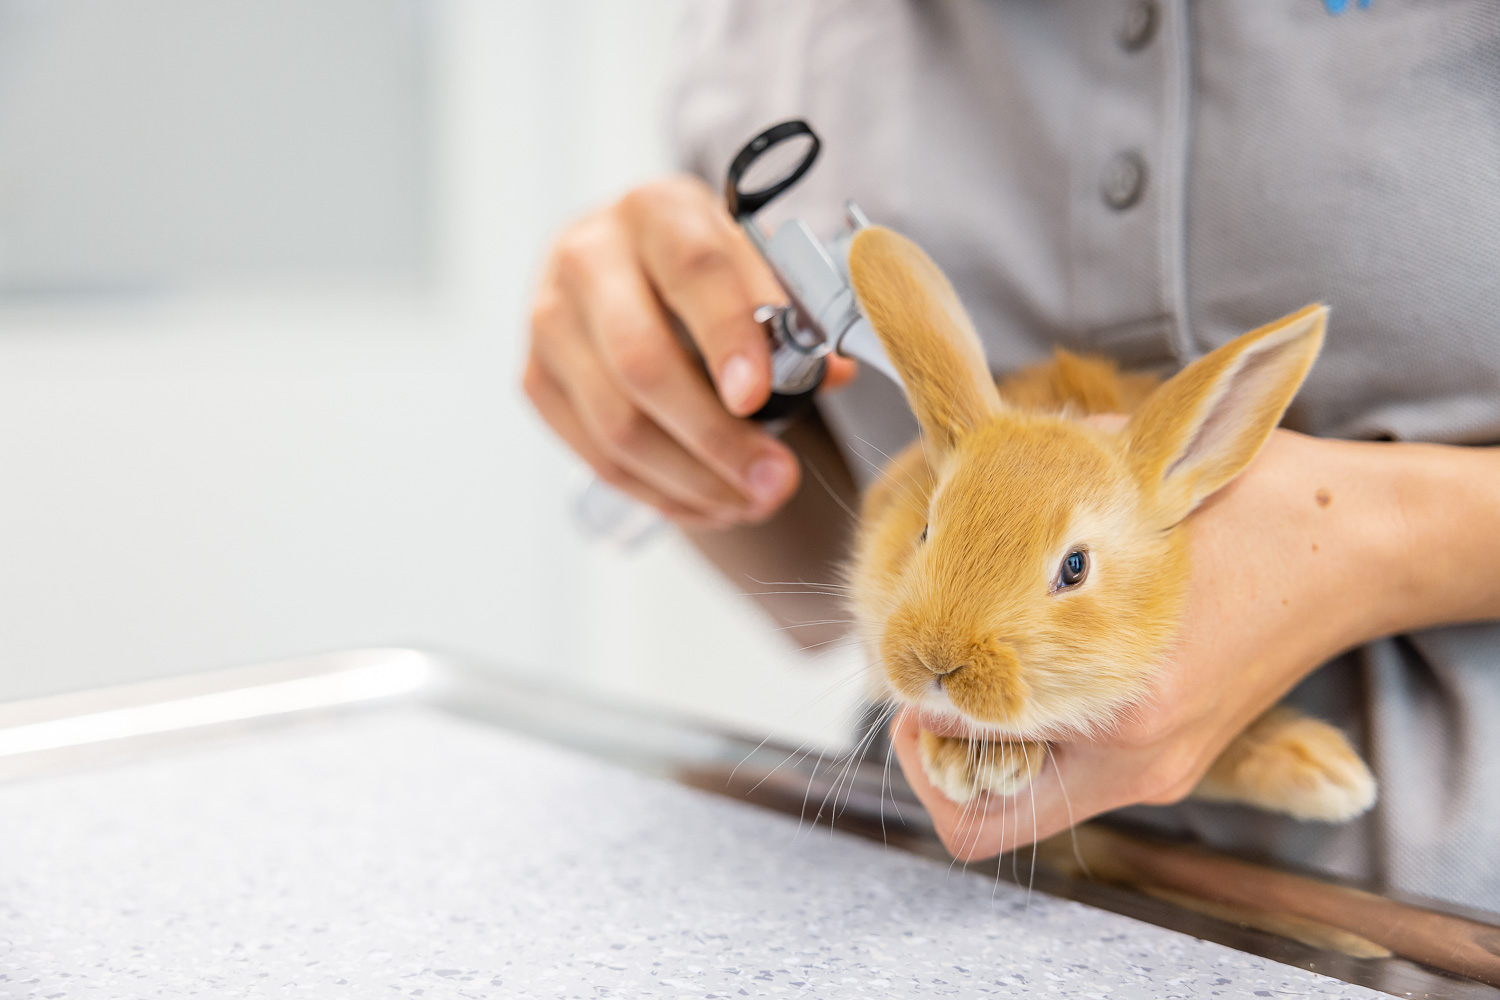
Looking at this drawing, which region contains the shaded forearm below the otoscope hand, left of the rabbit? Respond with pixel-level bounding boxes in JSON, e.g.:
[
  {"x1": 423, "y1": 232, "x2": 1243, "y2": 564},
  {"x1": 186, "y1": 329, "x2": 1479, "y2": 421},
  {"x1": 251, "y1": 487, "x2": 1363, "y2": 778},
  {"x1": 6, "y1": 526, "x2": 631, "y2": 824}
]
[{"x1": 684, "y1": 414, "x2": 858, "y2": 648}]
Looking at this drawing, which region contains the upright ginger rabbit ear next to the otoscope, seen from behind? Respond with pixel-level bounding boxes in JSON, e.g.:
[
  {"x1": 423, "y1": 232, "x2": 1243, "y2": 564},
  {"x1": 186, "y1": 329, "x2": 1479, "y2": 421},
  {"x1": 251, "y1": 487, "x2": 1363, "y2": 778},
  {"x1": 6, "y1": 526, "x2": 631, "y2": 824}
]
[{"x1": 849, "y1": 226, "x2": 1001, "y2": 454}]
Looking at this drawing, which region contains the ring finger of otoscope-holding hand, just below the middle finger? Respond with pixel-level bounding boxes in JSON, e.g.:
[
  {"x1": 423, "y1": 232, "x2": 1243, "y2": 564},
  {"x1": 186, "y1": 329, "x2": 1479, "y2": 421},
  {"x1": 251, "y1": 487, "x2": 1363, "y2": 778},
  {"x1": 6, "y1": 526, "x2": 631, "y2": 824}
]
[{"x1": 537, "y1": 301, "x2": 747, "y2": 523}]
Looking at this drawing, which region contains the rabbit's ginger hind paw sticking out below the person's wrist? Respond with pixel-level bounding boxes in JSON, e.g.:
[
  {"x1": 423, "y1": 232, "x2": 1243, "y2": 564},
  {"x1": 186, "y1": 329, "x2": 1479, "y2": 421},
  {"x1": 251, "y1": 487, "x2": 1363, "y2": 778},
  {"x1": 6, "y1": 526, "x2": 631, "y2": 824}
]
[{"x1": 1194, "y1": 708, "x2": 1376, "y2": 823}]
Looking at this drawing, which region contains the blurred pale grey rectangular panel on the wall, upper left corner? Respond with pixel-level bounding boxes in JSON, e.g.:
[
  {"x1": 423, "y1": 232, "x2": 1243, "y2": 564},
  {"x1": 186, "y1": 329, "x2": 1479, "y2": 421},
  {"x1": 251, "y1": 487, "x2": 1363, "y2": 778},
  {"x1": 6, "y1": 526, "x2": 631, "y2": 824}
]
[{"x1": 0, "y1": 0, "x2": 435, "y2": 292}]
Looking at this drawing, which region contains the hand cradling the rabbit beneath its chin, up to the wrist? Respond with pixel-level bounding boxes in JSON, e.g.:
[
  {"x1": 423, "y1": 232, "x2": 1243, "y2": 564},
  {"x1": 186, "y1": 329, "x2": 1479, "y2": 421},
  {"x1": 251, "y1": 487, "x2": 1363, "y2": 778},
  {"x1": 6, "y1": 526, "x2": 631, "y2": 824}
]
[{"x1": 891, "y1": 431, "x2": 1400, "y2": 861}]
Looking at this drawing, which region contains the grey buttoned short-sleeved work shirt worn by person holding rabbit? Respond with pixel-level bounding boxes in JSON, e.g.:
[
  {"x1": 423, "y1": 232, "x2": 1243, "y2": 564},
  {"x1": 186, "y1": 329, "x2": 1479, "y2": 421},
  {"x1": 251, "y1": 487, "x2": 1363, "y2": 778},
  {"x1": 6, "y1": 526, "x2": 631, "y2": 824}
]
[{"x1": 672, "y1": 0, "x2": 1500, "y2": 912}]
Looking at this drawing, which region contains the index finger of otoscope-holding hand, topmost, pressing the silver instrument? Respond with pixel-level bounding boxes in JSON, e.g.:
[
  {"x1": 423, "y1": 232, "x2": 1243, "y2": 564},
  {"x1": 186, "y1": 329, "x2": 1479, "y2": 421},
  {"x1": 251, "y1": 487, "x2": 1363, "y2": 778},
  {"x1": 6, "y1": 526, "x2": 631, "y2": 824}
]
[{"x1": 623, "y1": 181, "x2": 782, "y2": 417}]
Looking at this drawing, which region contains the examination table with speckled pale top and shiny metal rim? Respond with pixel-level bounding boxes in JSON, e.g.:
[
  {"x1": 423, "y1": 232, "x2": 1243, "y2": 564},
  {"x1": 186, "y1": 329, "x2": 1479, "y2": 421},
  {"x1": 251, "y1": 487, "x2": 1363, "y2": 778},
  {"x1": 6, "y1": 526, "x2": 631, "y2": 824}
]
[{"x1": 0, "y1": 649, "x2": 1500, "y2": 1000}]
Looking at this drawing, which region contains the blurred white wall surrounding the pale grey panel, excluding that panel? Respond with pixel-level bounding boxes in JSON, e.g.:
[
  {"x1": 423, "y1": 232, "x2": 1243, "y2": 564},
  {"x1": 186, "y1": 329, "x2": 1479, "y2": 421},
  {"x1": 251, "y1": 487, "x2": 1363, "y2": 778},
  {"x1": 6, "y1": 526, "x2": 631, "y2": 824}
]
[{"x1": 0, "y1": 0, "x2": 857, "y2": 749}]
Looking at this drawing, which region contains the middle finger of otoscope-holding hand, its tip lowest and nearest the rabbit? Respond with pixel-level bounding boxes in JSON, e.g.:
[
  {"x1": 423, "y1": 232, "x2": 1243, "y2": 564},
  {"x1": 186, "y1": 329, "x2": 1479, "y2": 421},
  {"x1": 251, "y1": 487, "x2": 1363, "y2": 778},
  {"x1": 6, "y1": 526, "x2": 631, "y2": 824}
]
[{"x1": 564, "y1": 223, "x2": 798, "y2": 519}]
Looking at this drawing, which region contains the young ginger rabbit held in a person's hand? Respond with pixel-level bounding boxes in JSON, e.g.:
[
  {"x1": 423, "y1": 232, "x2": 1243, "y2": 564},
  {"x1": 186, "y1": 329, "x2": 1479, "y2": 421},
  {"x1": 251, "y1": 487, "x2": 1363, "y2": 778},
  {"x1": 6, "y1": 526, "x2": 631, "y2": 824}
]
[{"x1": 848, "y1": 226, "x2": 1376, "y2": 822}]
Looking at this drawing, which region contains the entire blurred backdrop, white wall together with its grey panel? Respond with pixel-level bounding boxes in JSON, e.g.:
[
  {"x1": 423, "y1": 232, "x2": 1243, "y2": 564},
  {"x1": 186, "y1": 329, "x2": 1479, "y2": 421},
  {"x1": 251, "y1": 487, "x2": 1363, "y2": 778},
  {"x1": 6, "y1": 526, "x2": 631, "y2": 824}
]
[{"x1": 0, "y1": 0, "x2": 860, "y2": 742}]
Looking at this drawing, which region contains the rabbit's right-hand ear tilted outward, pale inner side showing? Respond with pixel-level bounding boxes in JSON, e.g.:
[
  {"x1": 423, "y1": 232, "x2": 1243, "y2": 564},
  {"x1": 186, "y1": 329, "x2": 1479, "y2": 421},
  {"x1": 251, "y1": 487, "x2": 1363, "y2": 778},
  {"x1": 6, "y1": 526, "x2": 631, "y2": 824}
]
[{"x1": 1125, "y1": 304, "x2": 1328, "y2": 522}]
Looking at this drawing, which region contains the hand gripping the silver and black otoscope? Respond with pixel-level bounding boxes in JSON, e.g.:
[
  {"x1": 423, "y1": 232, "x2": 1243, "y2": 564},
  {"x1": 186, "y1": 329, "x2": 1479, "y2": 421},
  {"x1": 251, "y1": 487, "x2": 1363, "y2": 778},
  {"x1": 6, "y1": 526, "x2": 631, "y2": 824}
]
[{"x1": 524, "y1": 177, "x2": 854, "y2": 528}]
